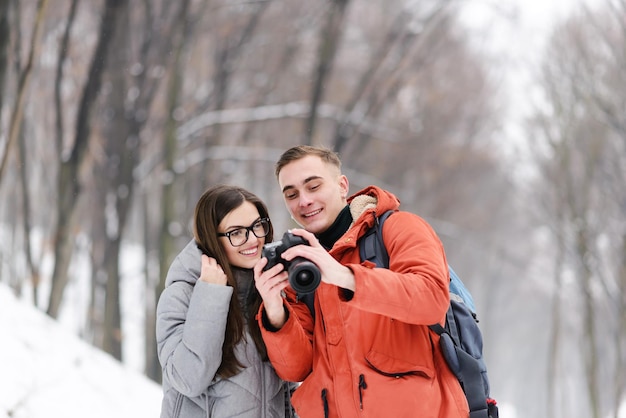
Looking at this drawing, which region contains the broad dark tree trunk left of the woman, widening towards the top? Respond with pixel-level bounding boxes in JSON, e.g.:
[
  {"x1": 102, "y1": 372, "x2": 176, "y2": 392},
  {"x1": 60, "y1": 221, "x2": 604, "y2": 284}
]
[{"x1": 97, "y1": 1, "x2": 183, "y2": 359}]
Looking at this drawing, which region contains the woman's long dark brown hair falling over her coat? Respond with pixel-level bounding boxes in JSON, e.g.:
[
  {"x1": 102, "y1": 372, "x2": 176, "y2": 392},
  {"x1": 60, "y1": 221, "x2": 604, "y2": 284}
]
[{"x1": 193, "y1": 185, "x2": 274, "y2": 378}]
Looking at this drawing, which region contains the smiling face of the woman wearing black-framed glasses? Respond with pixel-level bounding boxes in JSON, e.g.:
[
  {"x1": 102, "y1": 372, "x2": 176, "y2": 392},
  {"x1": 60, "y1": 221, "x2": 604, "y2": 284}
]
[{"x1": 217, "y1": 201, "x2": 265, "y2": 269}]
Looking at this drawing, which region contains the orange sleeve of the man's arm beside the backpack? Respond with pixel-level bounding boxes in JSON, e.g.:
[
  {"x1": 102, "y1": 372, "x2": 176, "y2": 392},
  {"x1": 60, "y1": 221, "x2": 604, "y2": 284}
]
[{"x1": 347, "y1": 212, "x2": 450, "y2": 325}]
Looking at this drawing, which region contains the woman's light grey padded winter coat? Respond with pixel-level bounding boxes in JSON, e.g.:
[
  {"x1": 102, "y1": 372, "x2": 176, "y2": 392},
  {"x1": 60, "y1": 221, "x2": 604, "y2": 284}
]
[{"x1": 156, "y1": 240, "x2": 291, "y2": 418}]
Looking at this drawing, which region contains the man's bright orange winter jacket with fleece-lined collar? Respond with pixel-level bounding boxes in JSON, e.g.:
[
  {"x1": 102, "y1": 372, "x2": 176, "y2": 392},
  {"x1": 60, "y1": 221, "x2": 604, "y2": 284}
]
[{"x1": 259, "y1": 186, "x2": 469, "y2": 418}]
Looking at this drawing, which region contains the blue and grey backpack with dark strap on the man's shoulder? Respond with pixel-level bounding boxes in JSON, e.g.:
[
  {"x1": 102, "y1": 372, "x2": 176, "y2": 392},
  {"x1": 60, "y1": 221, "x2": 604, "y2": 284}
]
[{"x1": 359, "y1": 210, "x2": 498, "y2": 418}]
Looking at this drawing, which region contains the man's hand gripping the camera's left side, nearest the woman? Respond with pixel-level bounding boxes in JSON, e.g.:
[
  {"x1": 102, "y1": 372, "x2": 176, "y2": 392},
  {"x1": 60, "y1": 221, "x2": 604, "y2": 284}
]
[{"x1": 254, "y1": 257, "x2": 289, "y2": 329}]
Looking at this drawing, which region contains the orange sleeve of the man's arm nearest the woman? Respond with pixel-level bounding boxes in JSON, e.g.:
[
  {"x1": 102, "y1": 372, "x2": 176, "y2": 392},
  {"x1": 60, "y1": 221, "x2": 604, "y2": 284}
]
[{"x1": 257, "y1": 300, "x2": 313, "y2": 382}]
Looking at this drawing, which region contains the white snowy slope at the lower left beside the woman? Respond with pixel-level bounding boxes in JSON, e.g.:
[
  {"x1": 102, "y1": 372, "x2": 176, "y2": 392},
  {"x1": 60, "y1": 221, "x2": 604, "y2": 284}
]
[{"x1": 0, "y1": 284, "x2": 162, "y2": 418}]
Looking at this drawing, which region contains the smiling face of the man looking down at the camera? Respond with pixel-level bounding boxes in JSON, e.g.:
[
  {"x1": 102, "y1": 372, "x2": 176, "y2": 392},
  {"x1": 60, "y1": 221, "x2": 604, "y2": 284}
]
[{"x1": 278, "y1": 155, "x2": 348, "y2": 234}]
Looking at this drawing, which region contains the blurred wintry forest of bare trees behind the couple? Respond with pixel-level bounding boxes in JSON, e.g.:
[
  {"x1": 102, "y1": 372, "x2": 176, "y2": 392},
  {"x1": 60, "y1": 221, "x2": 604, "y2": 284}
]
[{"x1": 0, "y1": 0, "x2": 626, "y2": 418}]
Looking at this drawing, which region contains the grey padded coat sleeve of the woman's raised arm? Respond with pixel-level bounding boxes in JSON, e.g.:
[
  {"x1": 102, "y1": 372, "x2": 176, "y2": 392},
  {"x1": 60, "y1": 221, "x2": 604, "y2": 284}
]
[{"x1": 156, "y1": 255, "x2": 233, "y2": 397}]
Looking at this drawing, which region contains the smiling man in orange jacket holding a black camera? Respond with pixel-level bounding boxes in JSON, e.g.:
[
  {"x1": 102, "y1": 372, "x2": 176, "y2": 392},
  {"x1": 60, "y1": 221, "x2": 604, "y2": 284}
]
[{"x1": 255, "y1": 146, "x2": 469, "y2": 418}]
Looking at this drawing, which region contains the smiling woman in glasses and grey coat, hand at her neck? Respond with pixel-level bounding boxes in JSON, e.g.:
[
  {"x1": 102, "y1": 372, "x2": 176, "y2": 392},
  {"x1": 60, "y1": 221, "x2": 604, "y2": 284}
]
[{"x1": 156, "y1": 186, "x2": 292, "y2": 418}]
